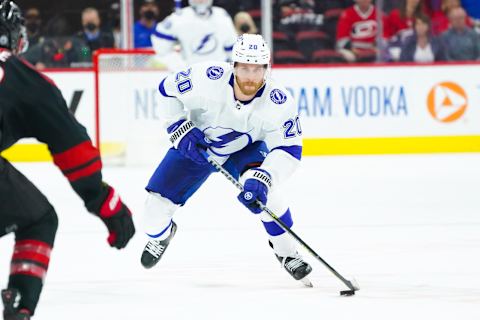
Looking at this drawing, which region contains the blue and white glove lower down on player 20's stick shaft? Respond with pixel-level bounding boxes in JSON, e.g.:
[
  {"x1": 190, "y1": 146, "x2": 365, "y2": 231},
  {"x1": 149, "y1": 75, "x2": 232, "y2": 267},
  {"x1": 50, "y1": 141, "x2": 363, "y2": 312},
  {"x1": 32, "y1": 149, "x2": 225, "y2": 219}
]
[{"x1": 238, "y1": 168, "x2": 272, "y2": 214}]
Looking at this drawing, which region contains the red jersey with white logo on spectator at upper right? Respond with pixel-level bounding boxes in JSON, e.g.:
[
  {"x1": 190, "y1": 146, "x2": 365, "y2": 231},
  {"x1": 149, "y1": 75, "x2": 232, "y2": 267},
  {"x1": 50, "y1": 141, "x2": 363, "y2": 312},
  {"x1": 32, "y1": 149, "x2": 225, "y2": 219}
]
[{"x1": 337, "y1": 5, "x2": 388, "y2": 51}]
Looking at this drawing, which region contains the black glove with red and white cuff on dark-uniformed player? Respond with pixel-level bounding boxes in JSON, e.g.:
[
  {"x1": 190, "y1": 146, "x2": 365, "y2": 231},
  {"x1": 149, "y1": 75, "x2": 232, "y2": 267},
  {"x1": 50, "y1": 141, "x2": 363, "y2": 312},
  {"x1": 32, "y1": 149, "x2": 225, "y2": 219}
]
[{"x1": 89, "y1": 183, "x2": 135, "y2": 249}]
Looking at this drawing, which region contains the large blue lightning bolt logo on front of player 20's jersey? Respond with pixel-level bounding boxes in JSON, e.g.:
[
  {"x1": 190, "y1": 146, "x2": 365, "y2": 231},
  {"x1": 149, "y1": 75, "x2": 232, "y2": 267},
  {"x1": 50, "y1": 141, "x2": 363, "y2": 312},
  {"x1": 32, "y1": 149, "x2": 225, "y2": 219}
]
[{"x1": 204, "y1": 127, "x2": 252, "y2": 157}]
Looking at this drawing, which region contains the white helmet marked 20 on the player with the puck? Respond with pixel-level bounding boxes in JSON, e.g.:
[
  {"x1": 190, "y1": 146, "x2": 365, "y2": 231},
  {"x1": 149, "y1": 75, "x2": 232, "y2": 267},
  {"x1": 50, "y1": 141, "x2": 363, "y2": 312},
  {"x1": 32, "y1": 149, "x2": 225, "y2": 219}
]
[{"x1": 232, "y1": 33, "x2": 270, "y2": 65}]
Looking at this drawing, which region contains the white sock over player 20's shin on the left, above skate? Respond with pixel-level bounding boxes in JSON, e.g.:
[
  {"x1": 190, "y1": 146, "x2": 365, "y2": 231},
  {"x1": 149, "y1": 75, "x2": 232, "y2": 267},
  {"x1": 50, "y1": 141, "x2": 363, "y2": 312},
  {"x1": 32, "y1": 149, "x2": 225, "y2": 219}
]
[{"x1": 143, "y1": 192, "x2": 179, "y2": 236}]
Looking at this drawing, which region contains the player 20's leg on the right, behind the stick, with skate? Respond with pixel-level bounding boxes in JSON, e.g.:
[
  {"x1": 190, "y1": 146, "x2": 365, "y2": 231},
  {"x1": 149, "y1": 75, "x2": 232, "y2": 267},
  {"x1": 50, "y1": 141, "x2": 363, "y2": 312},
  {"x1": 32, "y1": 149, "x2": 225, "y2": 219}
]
[{"x1": 224, "y1": 142, "x2": 312, "y2": 280}]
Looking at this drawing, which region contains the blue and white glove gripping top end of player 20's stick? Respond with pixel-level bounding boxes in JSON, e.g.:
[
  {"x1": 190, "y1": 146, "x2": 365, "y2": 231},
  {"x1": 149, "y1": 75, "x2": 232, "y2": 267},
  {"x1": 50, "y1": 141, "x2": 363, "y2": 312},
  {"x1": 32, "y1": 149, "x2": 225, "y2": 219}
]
[{"x1": 167, "y1": 119, "x2": 210, "y2": 165}]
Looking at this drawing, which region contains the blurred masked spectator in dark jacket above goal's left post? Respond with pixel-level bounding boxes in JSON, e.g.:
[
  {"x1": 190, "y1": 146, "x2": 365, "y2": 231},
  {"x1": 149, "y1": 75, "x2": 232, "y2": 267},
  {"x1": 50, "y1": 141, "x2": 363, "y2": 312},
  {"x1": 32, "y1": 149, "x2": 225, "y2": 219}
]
[{"x1": 77, "y1": 7, "x2": 114, "y2": 59}]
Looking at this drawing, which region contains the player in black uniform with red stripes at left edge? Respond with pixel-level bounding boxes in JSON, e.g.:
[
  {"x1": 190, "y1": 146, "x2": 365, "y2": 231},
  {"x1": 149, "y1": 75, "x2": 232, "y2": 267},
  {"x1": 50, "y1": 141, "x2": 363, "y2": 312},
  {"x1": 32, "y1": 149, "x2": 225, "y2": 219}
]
[{"x1": 0, "y1": 0, "x2": 135, "y2": 320}]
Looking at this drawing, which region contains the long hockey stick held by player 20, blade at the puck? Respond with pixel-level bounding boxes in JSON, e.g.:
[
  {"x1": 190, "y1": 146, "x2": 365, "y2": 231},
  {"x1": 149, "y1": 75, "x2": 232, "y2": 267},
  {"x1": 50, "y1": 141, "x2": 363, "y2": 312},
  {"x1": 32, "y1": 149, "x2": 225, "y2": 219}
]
[{"x1": 203, "y1": 151, "x2": 360, "y2": 296}]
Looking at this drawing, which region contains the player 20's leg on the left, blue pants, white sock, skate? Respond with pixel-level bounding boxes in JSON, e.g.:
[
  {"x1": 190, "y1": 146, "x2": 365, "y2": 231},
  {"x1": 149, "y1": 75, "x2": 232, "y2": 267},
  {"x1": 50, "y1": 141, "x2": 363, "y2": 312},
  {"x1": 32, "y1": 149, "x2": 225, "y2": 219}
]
[{"x1": 141, "y1": 148, "x2": 213, "y2": 268}]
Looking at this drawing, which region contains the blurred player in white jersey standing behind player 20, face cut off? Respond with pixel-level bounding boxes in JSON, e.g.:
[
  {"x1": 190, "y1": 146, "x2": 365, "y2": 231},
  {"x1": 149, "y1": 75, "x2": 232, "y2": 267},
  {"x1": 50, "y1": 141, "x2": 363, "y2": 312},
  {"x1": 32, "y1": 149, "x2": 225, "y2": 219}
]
[{"x1": 151, "y1": 0, "x2": 237, "y2": 67}]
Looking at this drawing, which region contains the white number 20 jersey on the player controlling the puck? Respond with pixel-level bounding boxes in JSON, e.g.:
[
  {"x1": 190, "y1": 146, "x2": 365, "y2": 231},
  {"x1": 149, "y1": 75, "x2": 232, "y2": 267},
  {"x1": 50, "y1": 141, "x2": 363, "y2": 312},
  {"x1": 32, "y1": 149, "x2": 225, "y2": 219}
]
[{"x1": 159, "y1": 62, "x2": 302, "y2": 183}]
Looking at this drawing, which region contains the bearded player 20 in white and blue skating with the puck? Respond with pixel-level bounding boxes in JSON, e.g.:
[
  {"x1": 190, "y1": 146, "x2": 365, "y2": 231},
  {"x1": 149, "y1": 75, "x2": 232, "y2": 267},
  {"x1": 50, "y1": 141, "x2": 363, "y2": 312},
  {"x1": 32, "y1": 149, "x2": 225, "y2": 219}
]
[{"x1": 141, "y1": 34, "x2": 312, "y2": 280}]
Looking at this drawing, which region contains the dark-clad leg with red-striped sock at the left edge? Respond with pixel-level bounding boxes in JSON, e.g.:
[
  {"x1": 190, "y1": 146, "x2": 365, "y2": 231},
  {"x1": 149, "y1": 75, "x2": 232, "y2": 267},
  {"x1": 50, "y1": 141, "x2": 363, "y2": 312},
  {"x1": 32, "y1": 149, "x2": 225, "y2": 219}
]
[{"x1": 0, "y1": 158, "x2": 58, "y2": 319}]
